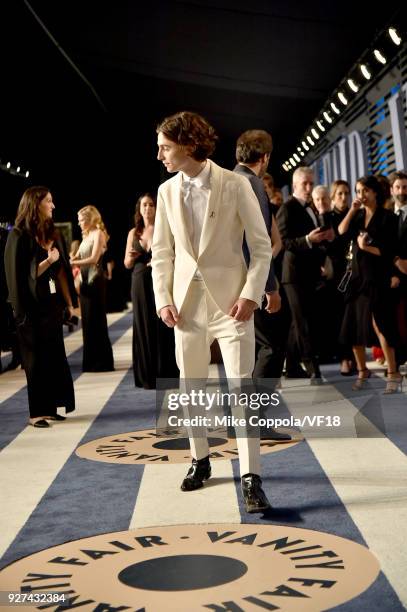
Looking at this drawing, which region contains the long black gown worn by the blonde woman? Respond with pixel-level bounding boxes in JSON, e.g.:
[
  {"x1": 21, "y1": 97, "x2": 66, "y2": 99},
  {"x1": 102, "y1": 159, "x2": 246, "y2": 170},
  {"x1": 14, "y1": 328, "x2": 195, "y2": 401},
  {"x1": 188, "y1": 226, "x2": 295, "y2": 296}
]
[{"x1": 79, "y1": 238, "x2": 114, "y2": 372}]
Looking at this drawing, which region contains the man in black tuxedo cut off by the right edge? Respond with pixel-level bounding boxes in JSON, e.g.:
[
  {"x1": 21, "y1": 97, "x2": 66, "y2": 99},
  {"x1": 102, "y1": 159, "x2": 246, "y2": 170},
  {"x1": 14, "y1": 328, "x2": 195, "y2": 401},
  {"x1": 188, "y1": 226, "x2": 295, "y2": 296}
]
[{"x1": 389, "y1": 171, "x2": 407, "y2": 366}]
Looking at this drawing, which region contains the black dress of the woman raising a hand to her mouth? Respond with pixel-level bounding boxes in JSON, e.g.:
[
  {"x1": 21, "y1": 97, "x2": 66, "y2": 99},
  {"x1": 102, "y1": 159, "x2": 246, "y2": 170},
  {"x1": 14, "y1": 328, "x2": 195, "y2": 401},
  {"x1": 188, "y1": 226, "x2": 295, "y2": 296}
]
[{"x1": 340, "y1": 208, "x2": 397, "y2": 347}]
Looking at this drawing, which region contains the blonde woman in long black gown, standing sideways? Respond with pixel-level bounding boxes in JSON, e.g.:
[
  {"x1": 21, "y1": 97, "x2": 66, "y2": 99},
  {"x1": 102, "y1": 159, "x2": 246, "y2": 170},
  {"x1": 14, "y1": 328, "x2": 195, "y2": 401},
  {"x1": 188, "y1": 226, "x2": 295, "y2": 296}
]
[{"x1": 71, "y1": 205, "x2": 114, "y2": 372}]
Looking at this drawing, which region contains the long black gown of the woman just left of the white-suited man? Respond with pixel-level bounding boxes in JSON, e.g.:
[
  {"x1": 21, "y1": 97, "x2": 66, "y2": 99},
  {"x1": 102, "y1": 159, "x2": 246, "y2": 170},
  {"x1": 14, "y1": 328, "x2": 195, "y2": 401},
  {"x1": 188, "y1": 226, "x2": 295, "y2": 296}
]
[{"x1": 131, "y1": 237, "x2": 179, "y2": 389}]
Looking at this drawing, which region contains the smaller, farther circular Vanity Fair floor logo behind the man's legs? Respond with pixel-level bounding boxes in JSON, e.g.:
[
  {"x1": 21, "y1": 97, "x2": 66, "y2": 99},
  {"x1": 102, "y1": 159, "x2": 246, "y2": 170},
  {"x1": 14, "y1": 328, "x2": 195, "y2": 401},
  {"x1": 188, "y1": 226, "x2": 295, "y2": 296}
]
[{"x1": 75, "y1": 429, "x2": 302, "y2": 464}]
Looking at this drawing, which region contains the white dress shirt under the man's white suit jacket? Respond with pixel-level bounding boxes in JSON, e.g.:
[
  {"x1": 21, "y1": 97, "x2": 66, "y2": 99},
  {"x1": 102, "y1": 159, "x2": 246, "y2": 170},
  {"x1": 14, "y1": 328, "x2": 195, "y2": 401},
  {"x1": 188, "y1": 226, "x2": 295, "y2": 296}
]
[{"x1": 182, "y1": 163, "x2": 211, "y2": 258}]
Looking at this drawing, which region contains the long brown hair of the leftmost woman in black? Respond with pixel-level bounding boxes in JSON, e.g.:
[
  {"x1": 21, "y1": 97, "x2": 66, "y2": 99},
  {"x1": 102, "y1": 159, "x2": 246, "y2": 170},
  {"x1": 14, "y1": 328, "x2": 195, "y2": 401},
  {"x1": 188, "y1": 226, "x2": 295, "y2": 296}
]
[{"x1": 15, "y1": 185, "x2": 56, "y2": 245}]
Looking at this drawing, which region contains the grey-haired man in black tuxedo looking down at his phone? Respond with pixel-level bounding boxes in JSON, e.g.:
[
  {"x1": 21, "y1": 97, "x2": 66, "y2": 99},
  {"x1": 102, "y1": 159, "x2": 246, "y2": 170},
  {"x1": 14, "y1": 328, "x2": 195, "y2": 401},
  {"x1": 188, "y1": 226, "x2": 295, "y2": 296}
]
[{"x1": 277, "y1": 166, "x2": 335, "y2": 385}]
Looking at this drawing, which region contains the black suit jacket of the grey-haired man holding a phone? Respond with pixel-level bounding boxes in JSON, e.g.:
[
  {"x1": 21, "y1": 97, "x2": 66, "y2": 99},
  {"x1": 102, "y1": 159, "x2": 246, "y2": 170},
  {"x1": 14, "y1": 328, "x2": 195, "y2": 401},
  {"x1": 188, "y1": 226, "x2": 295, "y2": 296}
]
[{"x1": 277, "y1": 197, "x2": 326, "y2": 285}]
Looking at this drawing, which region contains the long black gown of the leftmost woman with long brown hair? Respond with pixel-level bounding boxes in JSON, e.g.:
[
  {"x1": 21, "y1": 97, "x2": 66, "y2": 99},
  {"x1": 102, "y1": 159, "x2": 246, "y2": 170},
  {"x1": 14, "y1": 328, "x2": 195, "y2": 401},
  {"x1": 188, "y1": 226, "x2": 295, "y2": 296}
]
[{"x1": 5, "y1": 229, "x2": 75, "y2": 418}]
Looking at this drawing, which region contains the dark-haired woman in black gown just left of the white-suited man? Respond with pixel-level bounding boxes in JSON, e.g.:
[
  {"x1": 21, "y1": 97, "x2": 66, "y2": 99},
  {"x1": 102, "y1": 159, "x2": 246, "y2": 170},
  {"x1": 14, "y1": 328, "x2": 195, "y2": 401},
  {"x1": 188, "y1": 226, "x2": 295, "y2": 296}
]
[{"x1": 124, "y1": 193, "x2": 179, "y2": 389}]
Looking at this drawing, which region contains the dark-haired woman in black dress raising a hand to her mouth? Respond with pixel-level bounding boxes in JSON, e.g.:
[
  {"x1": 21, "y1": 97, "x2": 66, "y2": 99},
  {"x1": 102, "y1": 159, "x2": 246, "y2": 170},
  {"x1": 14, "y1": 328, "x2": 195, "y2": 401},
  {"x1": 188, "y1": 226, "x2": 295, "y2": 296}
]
[{"x1": 338, "y1": 176, "x2": 402, "y2": 393}]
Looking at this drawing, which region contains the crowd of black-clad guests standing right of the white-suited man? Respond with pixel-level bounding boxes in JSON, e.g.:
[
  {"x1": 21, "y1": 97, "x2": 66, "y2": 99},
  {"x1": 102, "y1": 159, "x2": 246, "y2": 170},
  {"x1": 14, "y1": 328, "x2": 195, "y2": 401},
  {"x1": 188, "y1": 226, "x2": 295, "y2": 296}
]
[{"x1": 265, "y1": 167, "x2": 407, "y2": 393}]
